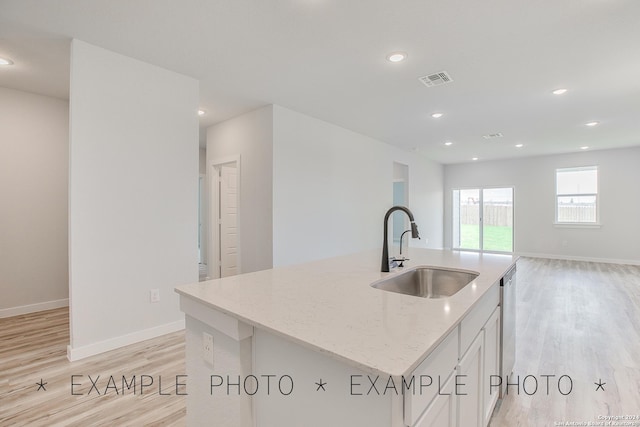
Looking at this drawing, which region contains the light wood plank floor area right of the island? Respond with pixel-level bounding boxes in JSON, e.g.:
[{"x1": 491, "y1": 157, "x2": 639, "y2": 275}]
[{"x1": 491, "y1": 258, "x2": 640, "y2": 427}]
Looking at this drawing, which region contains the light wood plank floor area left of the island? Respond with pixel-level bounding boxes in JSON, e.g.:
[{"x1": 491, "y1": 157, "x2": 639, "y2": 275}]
[{"x1": 0, "y1": 308, "x2": 186, "y2": 426}]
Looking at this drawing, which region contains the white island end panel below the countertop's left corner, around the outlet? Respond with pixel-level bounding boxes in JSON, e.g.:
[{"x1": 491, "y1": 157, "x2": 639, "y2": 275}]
[{"x1": 185, "y1": 313, "x2": 255, "y2": 427}]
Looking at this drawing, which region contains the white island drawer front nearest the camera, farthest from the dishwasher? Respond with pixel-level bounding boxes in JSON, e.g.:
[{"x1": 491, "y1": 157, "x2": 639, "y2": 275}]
[{"x1": 404, "y1": 327, "x2": 459, "y2": 426}]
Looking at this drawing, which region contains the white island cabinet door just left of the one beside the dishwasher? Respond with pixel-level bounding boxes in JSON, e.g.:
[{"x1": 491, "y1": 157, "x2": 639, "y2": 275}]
[{"x1": 455, "y1": 330, "x2": 484, "y2": 427}]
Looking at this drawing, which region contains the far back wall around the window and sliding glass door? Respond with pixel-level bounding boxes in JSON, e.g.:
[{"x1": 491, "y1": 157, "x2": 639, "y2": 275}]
[{"x1": 445, "y1": 148, "x2": 640, "y2": 263}]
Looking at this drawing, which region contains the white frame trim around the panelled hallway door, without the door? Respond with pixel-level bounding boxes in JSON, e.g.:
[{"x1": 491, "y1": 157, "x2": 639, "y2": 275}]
[{"x1": 207, "y1": 155, "x2": 242, "y2": 279}]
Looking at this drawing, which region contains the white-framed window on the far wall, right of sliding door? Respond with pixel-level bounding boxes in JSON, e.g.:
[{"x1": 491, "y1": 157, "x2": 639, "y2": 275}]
[{"x1": 556, "y1": 166, "x2": 598, "y2": 224}]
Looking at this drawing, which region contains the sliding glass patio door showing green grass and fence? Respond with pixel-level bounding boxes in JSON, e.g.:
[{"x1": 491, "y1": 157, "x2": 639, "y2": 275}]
[{"x1": 453, "y1": 187, "x2": 514, "y2": 253}]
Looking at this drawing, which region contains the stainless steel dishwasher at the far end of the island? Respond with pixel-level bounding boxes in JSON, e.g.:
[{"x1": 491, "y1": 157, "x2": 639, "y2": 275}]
[{"x1": 500, "y1": 265, "x2": 516, "y2": 398}]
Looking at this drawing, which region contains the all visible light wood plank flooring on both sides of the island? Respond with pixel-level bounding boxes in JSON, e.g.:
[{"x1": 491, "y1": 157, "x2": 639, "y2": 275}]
[{"x1": 0, "y1": 258, "x2": 640, "y2": 427}]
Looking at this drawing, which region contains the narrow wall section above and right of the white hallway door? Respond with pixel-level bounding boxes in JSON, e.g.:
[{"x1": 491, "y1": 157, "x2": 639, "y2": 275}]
[{"x1": 207, "y1": 106, "x2": 273, "y2": 273}]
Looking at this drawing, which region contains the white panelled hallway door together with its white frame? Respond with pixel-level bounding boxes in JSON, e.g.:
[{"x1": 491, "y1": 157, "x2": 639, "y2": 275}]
[{"x1": 208, "y1": 157, "x2": 241, "y2": 279}]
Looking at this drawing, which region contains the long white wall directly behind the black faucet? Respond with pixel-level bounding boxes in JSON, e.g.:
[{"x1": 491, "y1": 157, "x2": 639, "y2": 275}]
[{"x1": 273, "y1": 106, "x2": 443, "y2": 266}]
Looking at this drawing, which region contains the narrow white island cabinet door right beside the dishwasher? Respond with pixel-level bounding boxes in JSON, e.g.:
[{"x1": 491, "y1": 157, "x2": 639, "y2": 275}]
[{"x1": 482, "y1": 307, "x2": 500, "y2": 426}]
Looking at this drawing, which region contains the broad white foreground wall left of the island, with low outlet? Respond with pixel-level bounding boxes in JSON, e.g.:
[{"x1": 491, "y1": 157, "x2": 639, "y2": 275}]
[{"x1": 69, "y1": 40, "x2": 198, "y2": 359}]
